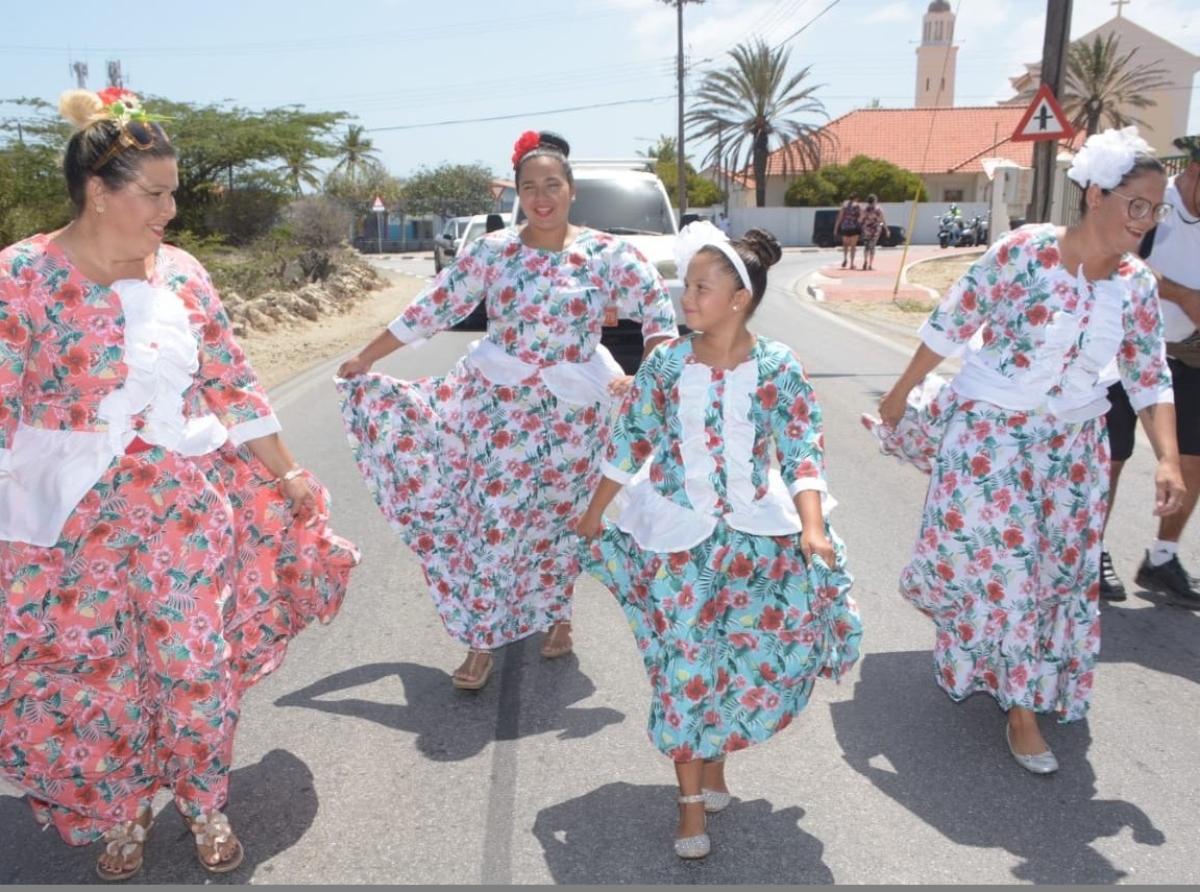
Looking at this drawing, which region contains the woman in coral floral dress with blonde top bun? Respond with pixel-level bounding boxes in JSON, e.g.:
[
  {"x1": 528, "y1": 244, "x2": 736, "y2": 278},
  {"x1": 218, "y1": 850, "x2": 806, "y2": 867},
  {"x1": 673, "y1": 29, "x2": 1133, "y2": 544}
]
[{"x1": 0, "y1": 89, "x2": 358, "y2": 880}]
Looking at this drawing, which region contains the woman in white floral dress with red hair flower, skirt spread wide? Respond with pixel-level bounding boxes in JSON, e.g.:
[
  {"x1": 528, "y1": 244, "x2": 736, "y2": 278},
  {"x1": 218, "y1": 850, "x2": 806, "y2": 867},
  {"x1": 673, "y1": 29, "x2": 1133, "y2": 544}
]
[{"x1": 337, "y1": 131, "x2": 678, "y2": 690}]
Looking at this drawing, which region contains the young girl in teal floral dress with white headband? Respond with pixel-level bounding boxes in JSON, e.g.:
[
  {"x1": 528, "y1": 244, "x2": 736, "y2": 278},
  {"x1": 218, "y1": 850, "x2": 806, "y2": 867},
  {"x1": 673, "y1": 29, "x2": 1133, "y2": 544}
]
[{"x1": 576, "y1": 222, "x2": 862, "y2": 858}]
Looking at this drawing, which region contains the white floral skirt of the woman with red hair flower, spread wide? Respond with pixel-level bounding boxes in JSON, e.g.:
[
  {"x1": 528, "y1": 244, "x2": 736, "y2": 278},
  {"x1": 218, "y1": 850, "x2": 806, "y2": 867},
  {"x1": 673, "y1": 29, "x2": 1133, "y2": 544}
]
[{"x1": 337, "y1": 360, "x2": 607, "y2": 649}]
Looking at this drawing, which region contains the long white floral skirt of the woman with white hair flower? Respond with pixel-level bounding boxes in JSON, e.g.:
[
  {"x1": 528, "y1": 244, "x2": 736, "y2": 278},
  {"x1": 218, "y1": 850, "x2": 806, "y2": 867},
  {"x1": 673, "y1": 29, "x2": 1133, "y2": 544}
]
[{"x1": 900, "y1": 387, "x2": 1109, "y2": 722}]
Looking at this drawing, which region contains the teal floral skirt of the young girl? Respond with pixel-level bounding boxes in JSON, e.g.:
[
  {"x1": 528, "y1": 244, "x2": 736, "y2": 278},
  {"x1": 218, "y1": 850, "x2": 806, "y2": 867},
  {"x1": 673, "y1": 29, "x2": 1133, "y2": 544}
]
[{"x1": 582, "y1": 521, "x2": 862, "y2": 762}]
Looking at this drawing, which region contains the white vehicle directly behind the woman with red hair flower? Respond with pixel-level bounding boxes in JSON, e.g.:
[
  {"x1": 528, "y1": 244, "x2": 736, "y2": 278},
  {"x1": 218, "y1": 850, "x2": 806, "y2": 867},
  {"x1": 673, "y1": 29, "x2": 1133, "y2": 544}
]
[{"x1": 512, "y1": 158, "x2": 688, "y2": 375}]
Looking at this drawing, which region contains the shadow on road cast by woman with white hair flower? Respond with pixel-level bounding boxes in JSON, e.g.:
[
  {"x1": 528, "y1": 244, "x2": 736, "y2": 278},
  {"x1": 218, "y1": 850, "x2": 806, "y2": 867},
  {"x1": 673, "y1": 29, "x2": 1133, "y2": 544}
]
[{"x1": 830, "y1": 652, "x2": 1165, "y2": 885}]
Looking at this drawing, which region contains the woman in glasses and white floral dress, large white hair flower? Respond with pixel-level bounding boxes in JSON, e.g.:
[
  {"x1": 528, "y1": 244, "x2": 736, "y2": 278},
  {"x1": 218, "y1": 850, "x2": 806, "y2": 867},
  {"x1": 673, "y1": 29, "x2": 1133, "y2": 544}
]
[{"x1": 876, "y1": 127, "x2": 1183, "y2": 774}]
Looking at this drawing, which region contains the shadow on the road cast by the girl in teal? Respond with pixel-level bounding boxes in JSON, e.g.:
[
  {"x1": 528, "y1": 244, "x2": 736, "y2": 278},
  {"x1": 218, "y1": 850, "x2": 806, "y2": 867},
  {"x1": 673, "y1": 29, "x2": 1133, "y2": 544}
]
[{"x1": 533, "y1": 783, "x2": 834, "y2": 887}]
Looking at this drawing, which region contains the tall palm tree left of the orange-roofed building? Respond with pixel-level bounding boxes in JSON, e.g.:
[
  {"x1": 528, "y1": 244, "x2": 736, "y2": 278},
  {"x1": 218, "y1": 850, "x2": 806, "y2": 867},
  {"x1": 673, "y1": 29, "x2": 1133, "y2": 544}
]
[{"x1": 688, "y1": 38, "x2": 829, "y2": 208}]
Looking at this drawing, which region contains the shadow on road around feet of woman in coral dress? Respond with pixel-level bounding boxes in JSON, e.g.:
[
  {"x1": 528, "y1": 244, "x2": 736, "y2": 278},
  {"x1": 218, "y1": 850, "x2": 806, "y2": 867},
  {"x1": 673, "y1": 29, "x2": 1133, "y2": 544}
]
[{"x1": 0, "y1": 749, "x2": 318, "y2": 886}]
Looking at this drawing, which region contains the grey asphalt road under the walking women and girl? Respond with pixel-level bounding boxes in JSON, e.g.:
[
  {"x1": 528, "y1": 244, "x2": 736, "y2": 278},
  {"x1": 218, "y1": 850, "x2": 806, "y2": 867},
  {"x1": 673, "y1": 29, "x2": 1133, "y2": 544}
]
[{"x1": 0, "y1": 252, "x2": 1200, "y2": 885}]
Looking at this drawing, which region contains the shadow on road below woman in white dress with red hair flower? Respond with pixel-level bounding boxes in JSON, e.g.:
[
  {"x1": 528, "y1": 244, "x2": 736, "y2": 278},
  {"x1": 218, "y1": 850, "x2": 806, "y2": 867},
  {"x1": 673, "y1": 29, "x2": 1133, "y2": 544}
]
[{"x1": 275, "y1": 641, "x2": 625, "y2": 762}]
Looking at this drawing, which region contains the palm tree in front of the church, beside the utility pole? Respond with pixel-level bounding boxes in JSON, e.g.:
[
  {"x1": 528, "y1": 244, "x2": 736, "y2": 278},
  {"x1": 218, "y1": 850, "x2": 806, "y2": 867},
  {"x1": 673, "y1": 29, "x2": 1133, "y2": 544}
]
[{"x1": 1062, "y1": 34, "x2": 1171, "y2": 136}]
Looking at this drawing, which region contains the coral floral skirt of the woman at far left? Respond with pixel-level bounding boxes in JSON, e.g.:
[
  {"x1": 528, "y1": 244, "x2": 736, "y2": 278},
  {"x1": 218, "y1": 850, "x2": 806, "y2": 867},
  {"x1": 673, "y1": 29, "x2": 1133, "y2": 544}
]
[{"x1": 0, "y1": 447, "x2": 359, "y2": 844}]
